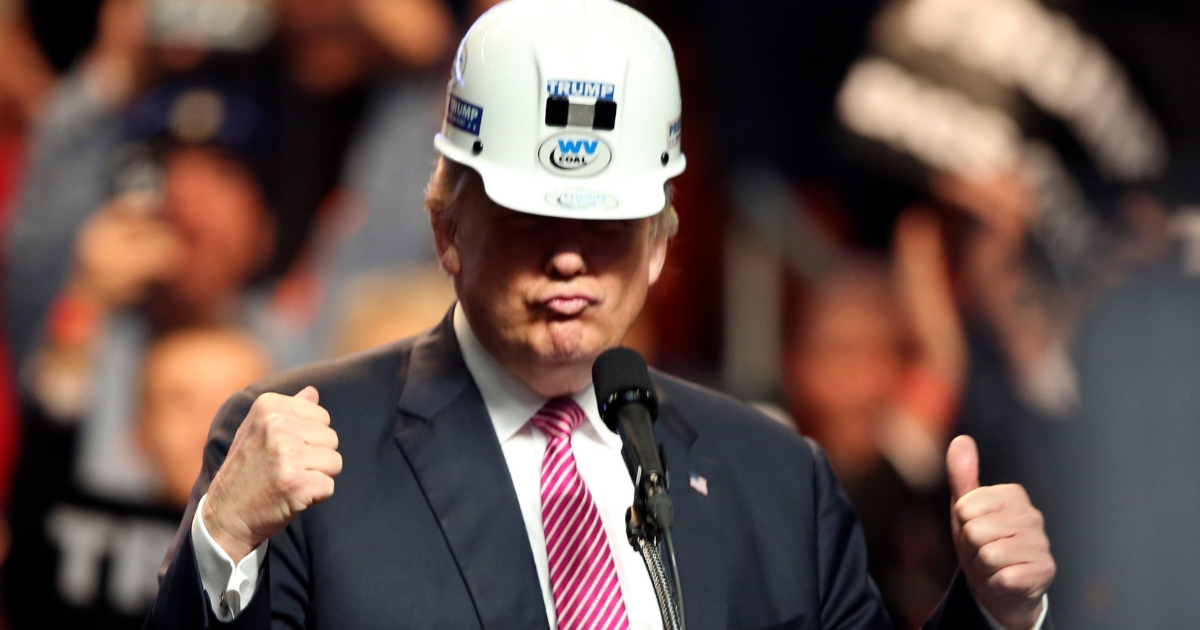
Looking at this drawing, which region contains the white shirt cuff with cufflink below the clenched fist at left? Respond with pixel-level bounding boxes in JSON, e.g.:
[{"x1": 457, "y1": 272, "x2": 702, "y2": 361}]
[{"x1": 192, "y1": 494, "x2": 266, "y2": 622}]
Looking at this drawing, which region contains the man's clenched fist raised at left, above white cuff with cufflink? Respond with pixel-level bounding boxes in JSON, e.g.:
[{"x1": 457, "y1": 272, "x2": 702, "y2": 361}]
[{"x1": 203, "y1": 385, "x2": 342, "y2": 563}]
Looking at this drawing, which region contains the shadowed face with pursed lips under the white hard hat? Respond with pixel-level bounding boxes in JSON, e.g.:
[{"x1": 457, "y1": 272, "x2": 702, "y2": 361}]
[{"x1": 437, "y1": 178, "x2": 667, "y2": 396}]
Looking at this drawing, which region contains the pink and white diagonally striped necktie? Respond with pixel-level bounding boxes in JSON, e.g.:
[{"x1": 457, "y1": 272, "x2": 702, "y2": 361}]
[{"x1": 530, "y1": 398, "x2": 629, "y2": 630}]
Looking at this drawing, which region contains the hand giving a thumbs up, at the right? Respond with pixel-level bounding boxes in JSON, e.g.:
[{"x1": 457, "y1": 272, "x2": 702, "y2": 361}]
[{"x1": 946, "y1": 436, "x2": 1055, "y2": 630}]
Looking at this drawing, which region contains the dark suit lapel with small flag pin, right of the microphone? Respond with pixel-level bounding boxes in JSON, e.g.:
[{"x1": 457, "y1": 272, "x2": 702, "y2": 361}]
[{"x1": 654, "y1": 376, "x2": 736, "y2": 630}]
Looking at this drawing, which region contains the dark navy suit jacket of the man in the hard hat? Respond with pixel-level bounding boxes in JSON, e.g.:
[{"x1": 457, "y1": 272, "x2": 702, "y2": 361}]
[{"x1": 146, "y1": 317, "x2": 988, "y2": 630}]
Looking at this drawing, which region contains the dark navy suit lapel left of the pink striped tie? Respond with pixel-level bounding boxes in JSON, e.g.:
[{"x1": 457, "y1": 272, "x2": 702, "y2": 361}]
[{"x1": 396, "y1": 310, "x2": 548, "y2": 630}]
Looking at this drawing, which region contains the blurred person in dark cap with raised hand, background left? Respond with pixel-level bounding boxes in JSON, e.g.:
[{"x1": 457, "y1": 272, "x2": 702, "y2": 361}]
[{"x1": 15, "y1": 80, "x2": 275, "y2": 500}]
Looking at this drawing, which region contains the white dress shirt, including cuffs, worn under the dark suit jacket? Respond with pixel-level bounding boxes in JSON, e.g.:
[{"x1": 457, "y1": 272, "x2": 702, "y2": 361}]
[{"x1": 192, "y1": 306, "x2": 1046, "y2": 630}]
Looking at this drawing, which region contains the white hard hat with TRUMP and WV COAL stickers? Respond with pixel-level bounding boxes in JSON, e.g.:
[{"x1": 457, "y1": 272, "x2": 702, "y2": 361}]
[{"x1": 433, "y1": 0, "x2": 686, "y2": 218}]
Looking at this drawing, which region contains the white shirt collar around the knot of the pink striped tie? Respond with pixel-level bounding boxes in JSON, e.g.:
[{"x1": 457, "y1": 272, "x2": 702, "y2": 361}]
[{"x1": 454, "y1": 304, "x2": 620, "y2": 450}]
